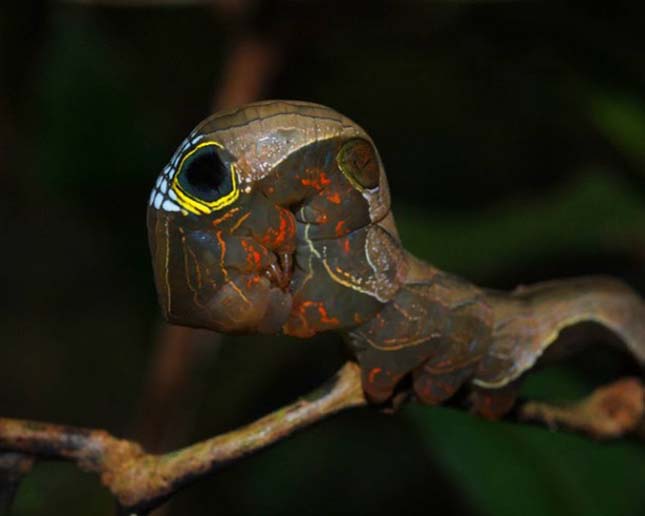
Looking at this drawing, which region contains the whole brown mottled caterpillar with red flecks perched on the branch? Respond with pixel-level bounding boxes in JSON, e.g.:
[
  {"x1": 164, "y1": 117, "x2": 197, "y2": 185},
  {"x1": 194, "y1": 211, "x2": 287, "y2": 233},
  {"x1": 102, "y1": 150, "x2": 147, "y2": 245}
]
[{"x1": 148, "y1": 101, "x2": 645, "y2": 418}]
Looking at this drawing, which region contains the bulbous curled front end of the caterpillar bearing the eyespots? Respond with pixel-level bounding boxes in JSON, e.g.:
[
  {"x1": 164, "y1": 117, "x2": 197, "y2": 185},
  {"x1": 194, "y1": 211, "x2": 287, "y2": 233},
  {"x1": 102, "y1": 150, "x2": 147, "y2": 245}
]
[{"x1": 148, "y1": 101, "x2": 406, "y2": 337}]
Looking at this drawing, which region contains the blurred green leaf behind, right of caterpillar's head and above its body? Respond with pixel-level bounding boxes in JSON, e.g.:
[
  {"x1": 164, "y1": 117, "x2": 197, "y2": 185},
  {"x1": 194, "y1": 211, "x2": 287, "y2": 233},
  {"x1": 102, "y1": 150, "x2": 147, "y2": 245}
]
[{"x1": 394, "y1": 172, "x2": 645, "y2": 279}]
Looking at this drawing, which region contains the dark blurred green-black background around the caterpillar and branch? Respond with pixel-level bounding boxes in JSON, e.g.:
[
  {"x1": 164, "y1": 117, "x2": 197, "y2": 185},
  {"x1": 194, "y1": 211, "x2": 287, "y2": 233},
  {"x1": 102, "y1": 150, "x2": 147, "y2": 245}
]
[{"x1": 0, "y1": 0, "x2": 645, "y2": 516}]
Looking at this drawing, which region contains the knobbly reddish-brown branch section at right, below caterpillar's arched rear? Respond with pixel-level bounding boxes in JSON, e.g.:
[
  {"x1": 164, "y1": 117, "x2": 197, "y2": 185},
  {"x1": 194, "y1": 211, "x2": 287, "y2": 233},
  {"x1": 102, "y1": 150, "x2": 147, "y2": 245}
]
[{"x1": 519, "y1": 378, "x2": 645, "y2": 439}]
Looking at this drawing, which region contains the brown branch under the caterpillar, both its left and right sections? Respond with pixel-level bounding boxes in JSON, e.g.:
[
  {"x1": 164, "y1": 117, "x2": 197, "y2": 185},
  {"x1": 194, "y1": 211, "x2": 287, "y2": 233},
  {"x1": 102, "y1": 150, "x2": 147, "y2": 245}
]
[{"x1": 0, "y1": 362, "x2": 645, "y2": 514}]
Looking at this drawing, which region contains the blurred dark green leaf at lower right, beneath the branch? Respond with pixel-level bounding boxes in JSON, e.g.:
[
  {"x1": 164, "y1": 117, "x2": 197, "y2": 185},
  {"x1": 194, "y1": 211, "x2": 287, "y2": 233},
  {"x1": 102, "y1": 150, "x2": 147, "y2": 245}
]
[{"x1": 404, "y1": 406, "x2": 645, "y2": 516}]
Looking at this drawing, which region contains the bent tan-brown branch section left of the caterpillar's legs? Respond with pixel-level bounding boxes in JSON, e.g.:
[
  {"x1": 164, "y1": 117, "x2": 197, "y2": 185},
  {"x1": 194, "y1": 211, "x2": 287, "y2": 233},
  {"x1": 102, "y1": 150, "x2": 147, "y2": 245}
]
[{"x1": 0, "y1": 362, "x2": 367, "y2": 512}]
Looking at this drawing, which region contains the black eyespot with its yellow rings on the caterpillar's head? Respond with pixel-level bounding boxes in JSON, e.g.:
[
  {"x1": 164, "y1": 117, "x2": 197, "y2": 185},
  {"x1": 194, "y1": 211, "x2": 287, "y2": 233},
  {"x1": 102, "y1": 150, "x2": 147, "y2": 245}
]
[{"x1": 172, "y1": 141, "x2": 240, "y2": 215}]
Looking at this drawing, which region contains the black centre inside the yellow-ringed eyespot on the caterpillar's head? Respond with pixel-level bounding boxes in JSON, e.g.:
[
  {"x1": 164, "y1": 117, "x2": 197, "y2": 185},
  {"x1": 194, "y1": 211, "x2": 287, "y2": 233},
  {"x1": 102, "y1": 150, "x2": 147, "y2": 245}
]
[{"x1": 179, "y1": 148, "x2": 233, "y2": 202}]
